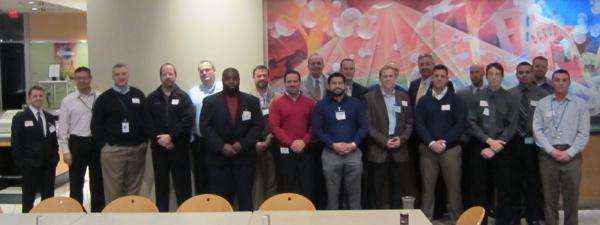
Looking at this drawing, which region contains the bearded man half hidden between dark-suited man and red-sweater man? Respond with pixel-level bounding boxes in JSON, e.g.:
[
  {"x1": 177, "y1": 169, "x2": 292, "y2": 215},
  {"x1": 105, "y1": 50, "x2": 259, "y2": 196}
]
[{"x1": 250, "y1": 65, "x2": 280, "y2": 207}]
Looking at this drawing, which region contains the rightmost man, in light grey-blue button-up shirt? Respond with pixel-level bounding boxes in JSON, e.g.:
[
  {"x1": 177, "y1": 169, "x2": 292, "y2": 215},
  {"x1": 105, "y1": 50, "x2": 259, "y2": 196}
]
[{"x1": 533, "y1": 69, "x2": 590, "y2": 225}]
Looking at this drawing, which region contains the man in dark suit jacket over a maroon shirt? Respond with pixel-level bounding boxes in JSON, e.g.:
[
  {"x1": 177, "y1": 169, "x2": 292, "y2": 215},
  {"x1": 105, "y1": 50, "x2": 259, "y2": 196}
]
[{"x1": 200, "y1": 68, "x2": 264, "y2": 211}]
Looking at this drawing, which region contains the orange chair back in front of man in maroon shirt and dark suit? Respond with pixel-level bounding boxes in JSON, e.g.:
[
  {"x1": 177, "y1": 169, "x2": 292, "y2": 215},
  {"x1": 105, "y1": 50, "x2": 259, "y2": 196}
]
[{"x1": 177, "y1": 194, "x2": 233, "y2": 212}]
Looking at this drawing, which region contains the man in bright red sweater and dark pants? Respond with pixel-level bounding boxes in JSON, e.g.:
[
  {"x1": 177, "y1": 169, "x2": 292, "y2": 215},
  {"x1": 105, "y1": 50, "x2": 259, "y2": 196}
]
[{"x1": 269, "y1": 71, "x2": 315, "y2": 198}]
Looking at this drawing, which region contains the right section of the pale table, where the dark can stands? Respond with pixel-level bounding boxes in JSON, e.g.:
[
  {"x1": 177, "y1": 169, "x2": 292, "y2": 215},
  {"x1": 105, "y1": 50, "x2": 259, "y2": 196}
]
[{"x1": 250, "y1": 209, "x2": 431, "y2": 225}]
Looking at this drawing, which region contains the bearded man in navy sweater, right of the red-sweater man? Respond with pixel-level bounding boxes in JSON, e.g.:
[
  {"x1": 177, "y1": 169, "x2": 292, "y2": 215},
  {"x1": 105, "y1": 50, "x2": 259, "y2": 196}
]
[{"x1": 312, "y1": 73, "x2": 368, "y2": 209}]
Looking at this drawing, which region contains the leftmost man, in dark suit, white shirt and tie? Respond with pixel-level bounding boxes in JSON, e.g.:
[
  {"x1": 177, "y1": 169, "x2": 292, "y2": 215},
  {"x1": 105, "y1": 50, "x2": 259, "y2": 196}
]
[{"x1": 11, "y1": 86, "x2": 58, "y2": 213}]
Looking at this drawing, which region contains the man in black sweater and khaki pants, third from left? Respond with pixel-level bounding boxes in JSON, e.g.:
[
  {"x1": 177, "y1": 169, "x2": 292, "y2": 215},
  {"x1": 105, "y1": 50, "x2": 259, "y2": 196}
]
[{"x1": 91, "y1": 64, "x2": 147, "y2": 204}]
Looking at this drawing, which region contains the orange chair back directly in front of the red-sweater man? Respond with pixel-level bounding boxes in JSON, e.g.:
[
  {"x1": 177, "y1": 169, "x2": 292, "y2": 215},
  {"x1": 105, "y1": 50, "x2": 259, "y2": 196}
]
[{"x1": 258, "y1": 193, "x2": 317, "y2": 211}]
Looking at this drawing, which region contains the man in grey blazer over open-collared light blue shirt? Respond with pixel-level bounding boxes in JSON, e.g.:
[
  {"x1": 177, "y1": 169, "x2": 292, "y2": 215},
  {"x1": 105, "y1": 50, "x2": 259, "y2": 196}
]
[{"x1": 365, "y1": 65, "x2": 417, "y2": 209}]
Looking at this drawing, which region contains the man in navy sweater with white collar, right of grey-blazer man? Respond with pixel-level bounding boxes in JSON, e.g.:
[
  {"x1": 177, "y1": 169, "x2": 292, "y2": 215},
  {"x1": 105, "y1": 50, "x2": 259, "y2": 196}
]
[{"x1": 415, "y1": 65, "x2": 467, "y2": 221}]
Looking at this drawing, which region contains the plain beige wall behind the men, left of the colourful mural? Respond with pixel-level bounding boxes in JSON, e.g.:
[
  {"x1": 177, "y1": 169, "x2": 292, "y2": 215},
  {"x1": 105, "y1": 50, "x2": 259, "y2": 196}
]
[{"x1": 87, "y1": 0, "x2": 264, "y2": 94}]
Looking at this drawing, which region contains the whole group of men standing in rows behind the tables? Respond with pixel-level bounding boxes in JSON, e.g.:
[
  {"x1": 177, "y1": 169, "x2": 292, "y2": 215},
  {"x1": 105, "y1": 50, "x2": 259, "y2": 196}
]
[{"x1": 12, "y1": 54, "x2": 590, "y2": 224}]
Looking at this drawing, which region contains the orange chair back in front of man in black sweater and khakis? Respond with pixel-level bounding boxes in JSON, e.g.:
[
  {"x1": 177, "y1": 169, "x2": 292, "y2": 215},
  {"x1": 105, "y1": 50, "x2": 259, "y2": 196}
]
[{"x1": 102, "y1": 195, "x2": 158, "y2": 213}]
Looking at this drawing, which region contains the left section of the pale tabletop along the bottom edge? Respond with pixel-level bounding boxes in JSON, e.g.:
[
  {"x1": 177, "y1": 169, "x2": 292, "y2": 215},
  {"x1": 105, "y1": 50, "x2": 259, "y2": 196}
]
[{"x1": 0, "y1": 212, "x2": 252, "y2": 225}]
